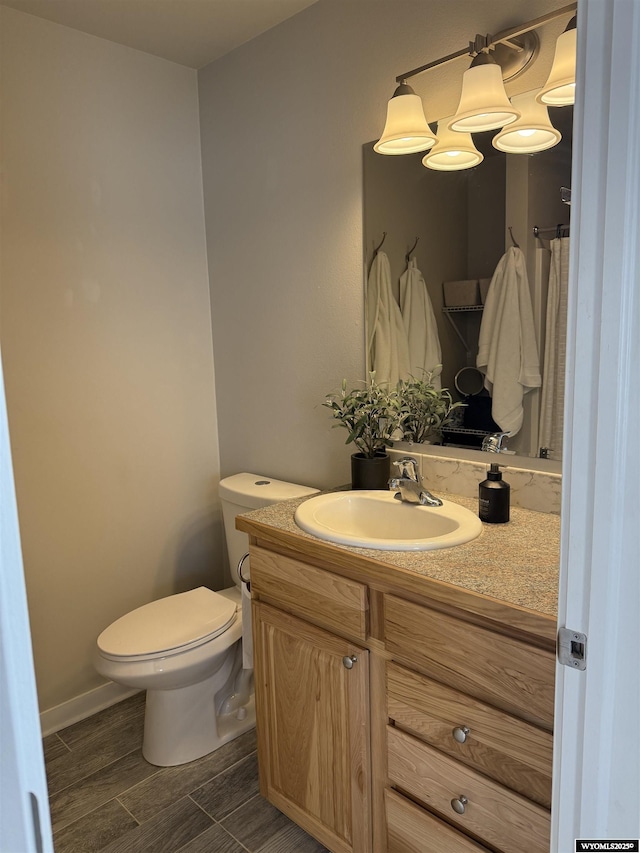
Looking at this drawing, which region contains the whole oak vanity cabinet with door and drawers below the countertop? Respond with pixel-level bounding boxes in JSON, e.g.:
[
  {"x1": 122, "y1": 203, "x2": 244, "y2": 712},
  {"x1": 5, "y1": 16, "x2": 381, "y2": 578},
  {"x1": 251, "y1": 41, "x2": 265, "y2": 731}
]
[{"x1": 245, "y1": 524, "x2": 555, "y2": 853}]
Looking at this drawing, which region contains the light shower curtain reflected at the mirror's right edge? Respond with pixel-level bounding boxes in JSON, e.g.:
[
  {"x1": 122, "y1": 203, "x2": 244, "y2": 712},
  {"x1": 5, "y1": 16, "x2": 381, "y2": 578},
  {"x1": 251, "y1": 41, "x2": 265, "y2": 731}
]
[{"x1": 539, "y1": 237, "x2": 569, "y2": 459}]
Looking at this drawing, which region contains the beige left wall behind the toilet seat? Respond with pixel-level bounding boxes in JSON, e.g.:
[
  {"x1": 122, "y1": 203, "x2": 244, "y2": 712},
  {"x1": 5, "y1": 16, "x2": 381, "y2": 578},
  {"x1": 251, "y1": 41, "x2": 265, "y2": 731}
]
[{"x1": 0, "y1": 9, "x2": 221, "y2": 710}]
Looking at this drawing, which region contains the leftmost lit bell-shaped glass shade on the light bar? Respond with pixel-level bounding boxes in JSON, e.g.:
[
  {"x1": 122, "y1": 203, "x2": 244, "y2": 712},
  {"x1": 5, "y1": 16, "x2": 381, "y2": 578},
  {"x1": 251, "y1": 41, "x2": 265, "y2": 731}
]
[{"x1": 373, "y1": 83, "x2": 436, "y2": 154}]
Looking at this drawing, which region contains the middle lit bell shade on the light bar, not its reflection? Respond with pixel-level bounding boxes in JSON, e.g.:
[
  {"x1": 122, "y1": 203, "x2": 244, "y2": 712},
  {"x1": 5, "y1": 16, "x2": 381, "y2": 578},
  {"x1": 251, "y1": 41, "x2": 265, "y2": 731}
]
[{"x1": 449, "y1": 57, "x2": 520, "y2": 133}]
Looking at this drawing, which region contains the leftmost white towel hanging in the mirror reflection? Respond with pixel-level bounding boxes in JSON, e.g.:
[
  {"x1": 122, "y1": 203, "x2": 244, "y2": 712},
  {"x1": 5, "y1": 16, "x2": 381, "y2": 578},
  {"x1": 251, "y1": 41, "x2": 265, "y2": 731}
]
[{"x1": 365, "y1": 252, "x2": 409, "y2": 386}]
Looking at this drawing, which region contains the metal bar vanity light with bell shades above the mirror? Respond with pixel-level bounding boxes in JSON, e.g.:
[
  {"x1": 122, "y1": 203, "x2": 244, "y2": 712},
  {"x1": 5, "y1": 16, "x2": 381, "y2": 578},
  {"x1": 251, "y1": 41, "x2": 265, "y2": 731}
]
[{"x1": 373, "y1": 2, "x2": 577, "y2": 156}]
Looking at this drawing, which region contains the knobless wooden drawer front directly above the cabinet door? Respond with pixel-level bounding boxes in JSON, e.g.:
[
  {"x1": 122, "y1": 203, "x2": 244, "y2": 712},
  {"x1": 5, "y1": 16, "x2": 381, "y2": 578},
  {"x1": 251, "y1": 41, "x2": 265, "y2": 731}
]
[{"x1": 251, "y1": 546, "x2": 368, "y2": 640}]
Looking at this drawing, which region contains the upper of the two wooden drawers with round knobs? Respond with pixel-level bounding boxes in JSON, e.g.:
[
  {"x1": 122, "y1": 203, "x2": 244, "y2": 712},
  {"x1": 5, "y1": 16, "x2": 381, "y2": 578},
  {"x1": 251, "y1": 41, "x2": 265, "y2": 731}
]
[{"x1": 387, "y1": 663, "x2": 553, "y2": 808}]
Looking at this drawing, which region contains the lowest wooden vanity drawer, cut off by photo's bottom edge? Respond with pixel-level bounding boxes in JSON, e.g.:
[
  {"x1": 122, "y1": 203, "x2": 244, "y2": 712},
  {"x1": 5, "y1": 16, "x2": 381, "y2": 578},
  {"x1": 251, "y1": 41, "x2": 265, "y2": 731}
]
[{"x1": 384, "y1": 790, "x2": 488, "y2": 853}]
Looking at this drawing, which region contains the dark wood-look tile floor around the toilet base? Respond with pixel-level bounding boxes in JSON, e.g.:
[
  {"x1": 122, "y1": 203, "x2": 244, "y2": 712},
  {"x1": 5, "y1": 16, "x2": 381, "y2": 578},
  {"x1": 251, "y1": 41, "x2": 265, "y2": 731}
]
[{"x1": 44, "y1": 693, "x2": 328, "y2": 853}]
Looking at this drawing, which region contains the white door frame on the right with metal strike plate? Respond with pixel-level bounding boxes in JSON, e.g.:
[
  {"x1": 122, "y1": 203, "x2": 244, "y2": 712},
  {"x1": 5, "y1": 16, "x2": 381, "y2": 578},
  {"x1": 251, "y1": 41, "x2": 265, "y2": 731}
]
[{"x1": 550, "y1": 0, "x2": 640, "y2": 853}]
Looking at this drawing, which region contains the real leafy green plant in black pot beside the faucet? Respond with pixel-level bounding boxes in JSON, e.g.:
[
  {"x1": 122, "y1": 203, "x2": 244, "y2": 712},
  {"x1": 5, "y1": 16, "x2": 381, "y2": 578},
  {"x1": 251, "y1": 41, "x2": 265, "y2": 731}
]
[{"x1": 323, "y1": 372, "x2": 403, "y2": 489}]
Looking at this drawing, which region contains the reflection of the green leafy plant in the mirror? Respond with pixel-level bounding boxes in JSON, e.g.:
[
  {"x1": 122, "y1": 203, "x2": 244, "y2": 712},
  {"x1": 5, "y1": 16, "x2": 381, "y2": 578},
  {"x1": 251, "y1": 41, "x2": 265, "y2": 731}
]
[{"x1": 397, "y1": 372, "x2": 465, "y2": 444}]
